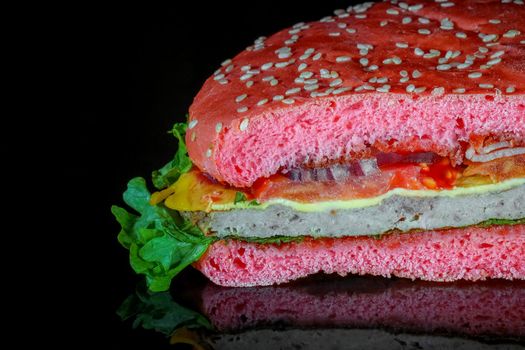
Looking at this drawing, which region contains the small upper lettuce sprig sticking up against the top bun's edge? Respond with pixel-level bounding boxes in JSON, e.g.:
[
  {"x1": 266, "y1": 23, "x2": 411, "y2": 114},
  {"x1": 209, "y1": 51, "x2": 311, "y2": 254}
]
[{"x1": 151, "y1": 123, "x2": 193, "y2": 190}]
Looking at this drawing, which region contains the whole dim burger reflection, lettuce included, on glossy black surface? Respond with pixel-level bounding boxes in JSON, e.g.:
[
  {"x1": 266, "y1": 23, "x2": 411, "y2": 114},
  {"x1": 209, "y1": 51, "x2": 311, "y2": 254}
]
[{"x1": 118, "y1": 276, "x2": 525, "y2": 350}]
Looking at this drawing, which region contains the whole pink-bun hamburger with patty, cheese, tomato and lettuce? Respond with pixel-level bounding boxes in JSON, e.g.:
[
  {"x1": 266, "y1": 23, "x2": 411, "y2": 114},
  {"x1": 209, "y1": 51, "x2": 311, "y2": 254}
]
[{"x1": 113, "y1": 1, "x2": 525, "y2": 291}]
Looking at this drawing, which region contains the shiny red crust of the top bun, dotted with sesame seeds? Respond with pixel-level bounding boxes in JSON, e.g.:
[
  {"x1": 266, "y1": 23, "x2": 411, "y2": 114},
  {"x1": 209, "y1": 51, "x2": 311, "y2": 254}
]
[{"x1": 188, "y1": 0, "x2": 525, "y2": 175}]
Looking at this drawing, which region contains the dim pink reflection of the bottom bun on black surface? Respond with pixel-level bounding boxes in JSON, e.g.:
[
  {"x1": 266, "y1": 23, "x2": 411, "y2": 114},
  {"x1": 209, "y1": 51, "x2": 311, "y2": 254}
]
[{"x1": 202, "y1": 278, "x2": 525, "y2": 337}]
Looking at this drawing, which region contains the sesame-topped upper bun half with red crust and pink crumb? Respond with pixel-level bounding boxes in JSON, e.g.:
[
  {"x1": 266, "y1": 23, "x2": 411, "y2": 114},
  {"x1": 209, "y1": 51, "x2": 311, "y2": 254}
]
[{"x1": 186, "y1": 0, "x2": 525, "y2": 187}]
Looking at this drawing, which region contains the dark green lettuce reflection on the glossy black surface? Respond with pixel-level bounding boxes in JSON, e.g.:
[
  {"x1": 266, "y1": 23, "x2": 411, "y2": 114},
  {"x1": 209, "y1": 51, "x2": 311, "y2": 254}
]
[{"x1": 117, "y1": 291, "x2": 212, "y2": 335}]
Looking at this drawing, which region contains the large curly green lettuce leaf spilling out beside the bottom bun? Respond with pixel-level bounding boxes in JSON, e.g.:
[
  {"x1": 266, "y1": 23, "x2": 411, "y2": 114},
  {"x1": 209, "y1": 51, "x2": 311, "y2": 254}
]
[{"x1": 111, "y1": 177, "x2": 215, "y2": 291}]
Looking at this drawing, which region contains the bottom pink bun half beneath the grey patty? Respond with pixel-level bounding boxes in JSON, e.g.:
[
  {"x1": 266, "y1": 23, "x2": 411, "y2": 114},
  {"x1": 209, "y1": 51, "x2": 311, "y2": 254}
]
[{"x1": 195, "y1": 224, "x2": 525, "y2": 286}]
